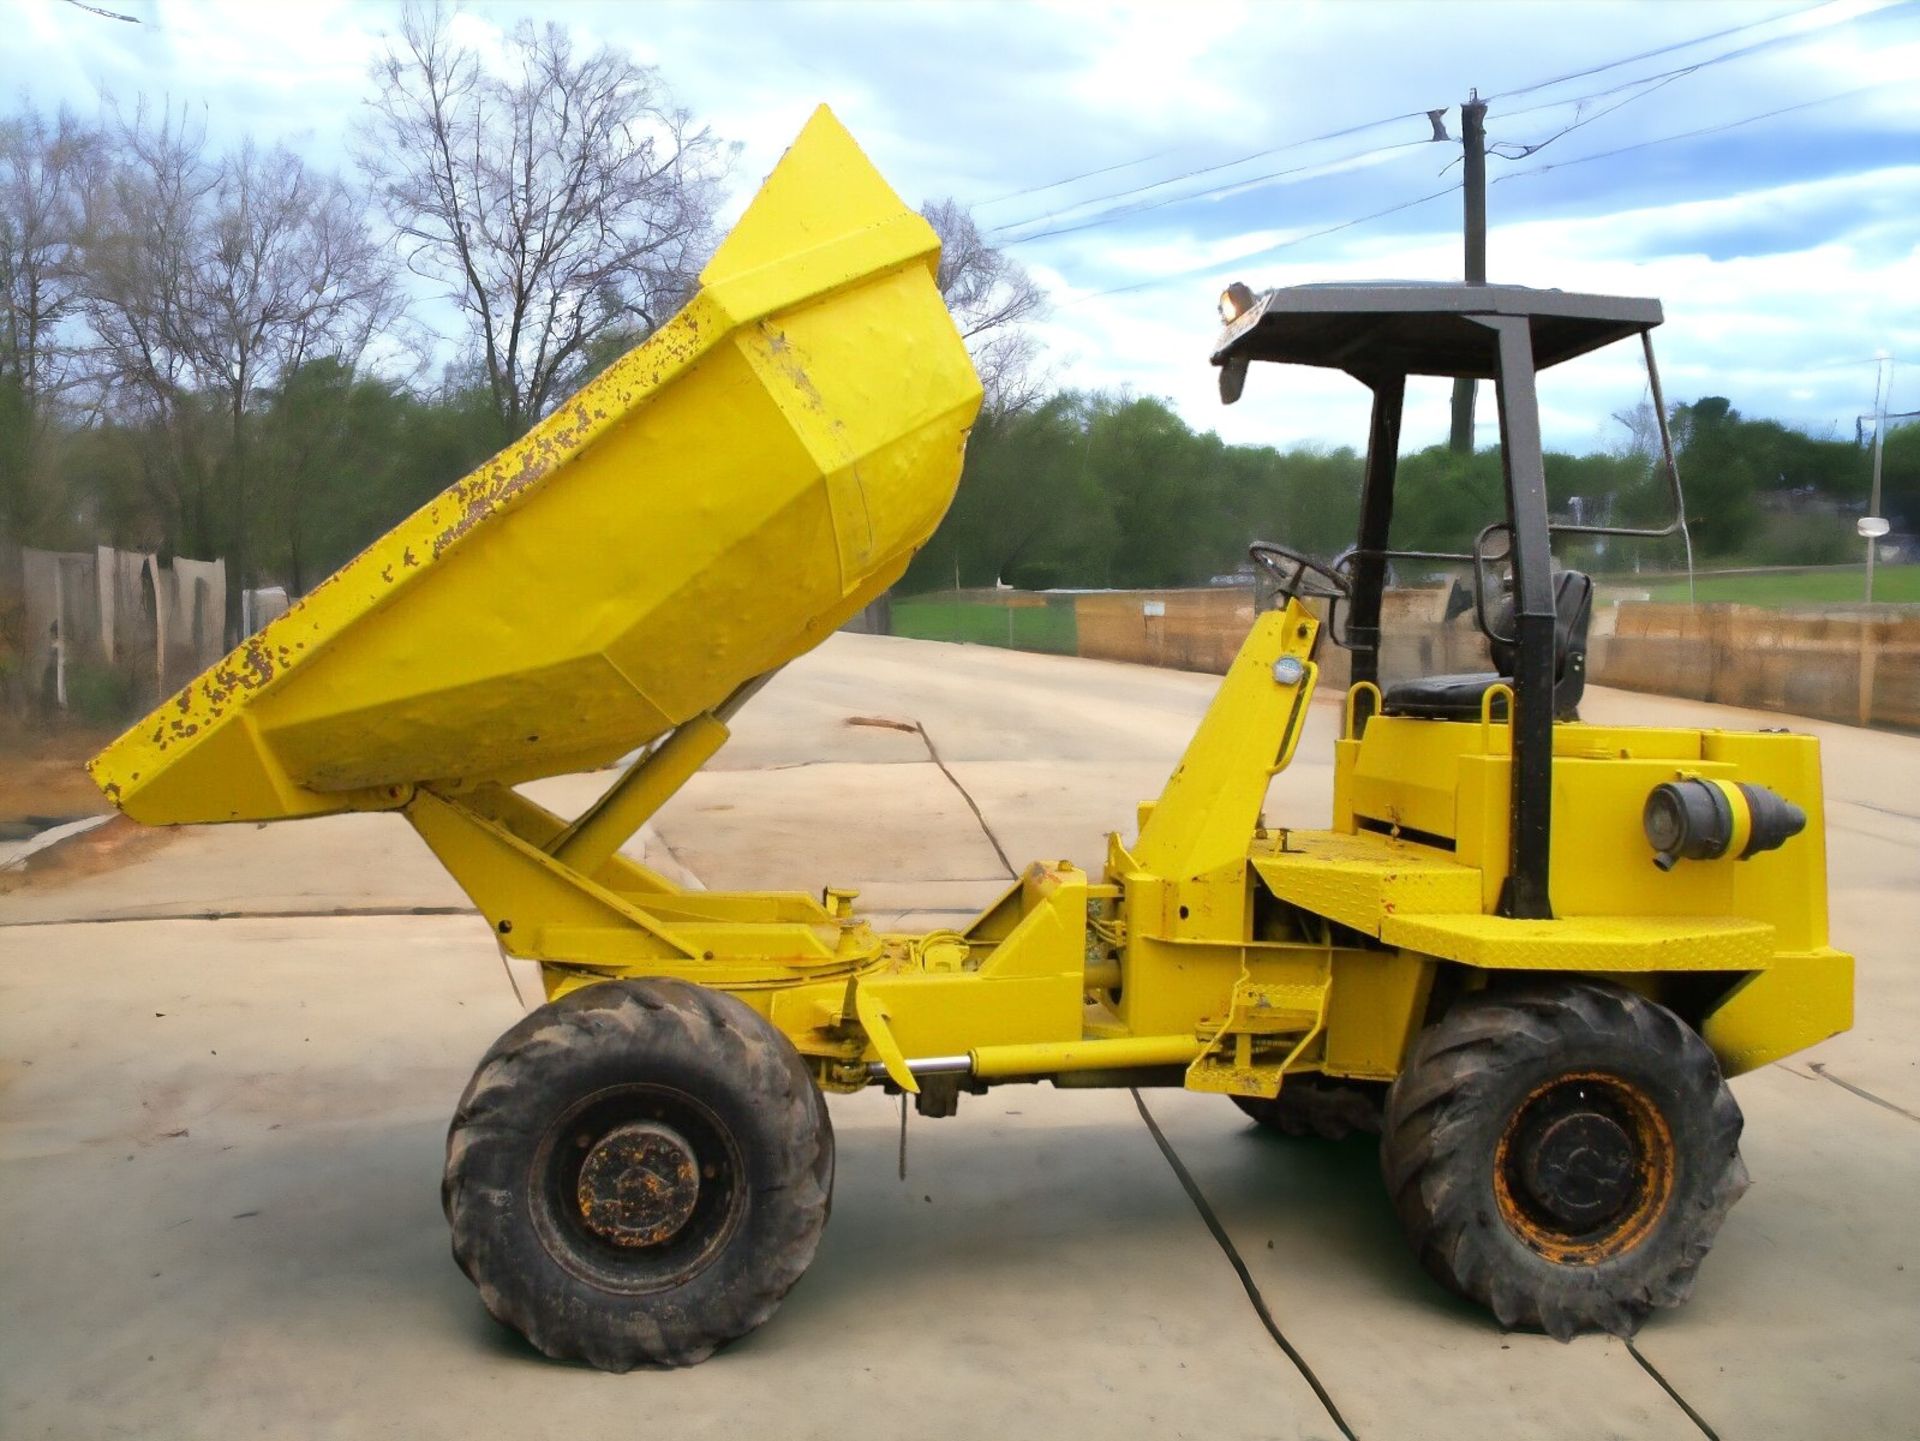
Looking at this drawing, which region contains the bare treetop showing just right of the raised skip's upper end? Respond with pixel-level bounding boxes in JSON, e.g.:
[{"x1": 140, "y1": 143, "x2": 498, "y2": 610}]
[{"x1": 920, "y1": 200, "x2": 1046, "y2": 418}]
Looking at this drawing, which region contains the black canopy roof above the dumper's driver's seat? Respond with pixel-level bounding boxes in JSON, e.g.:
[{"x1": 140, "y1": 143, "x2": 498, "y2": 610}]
[{"x1": 1213, "y1": 280, "x2": 1663, "y2": 380}]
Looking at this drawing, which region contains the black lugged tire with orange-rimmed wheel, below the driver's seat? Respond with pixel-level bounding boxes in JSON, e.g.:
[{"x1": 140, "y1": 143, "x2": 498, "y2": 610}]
[{"x1": 1380, "y1": 980, "x2": 1747, "y2": 1341}]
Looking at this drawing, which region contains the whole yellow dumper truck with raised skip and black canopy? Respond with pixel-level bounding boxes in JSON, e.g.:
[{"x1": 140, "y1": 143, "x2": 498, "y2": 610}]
[{"x1": 92, "y1": 109, "x2": 1851, "y2": 1370}]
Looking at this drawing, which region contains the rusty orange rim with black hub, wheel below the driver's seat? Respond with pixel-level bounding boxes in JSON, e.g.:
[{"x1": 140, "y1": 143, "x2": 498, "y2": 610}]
[{"x1": 1494, "y1": 1071, "x2": 1674, "y2": 1266}]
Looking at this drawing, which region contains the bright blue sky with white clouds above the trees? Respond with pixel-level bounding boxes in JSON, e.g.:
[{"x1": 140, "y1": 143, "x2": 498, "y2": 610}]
[{"x1": 0, "y1": 0, "x2": 1920, "y2": 451}]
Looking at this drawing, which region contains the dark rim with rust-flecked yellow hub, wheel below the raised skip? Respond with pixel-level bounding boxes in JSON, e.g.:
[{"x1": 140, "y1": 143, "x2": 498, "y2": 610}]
[{"x1": 528, "y1": 1084, "x2": 749, "y2": 1295}]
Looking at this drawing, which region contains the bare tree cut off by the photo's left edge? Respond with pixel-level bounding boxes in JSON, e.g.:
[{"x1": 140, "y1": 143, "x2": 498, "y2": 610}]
[{"x1": 0, "y1": 109, "x2": 100, "y2": 535}]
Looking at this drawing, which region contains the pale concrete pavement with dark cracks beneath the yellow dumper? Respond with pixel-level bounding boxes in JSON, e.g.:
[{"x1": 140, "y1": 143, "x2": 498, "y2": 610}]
[{"x1": 0, "y1": 635, "x2": 1920, "y2": 1441}]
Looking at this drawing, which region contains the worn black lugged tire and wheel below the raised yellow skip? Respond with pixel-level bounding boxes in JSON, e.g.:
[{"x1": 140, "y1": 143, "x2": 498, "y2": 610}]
[{"x1": 442, "y1": 980, "x2": 833, "y2": 1372}]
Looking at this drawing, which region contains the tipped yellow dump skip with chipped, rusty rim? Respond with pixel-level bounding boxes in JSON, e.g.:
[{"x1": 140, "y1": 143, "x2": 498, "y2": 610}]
[{"x1": 90, "y1": 107, "x2": 981, "y2": 825}]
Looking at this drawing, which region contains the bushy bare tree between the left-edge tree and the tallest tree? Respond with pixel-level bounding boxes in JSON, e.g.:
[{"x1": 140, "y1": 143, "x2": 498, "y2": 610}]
[{"x1": 84, "y1": 107, "x2": 403, "y2": 616}]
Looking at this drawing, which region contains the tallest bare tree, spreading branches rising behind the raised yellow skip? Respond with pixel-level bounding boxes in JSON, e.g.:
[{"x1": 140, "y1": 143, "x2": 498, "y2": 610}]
[{"x1": 363, "y1": 6, "x2": 732, "y2": 436}]
